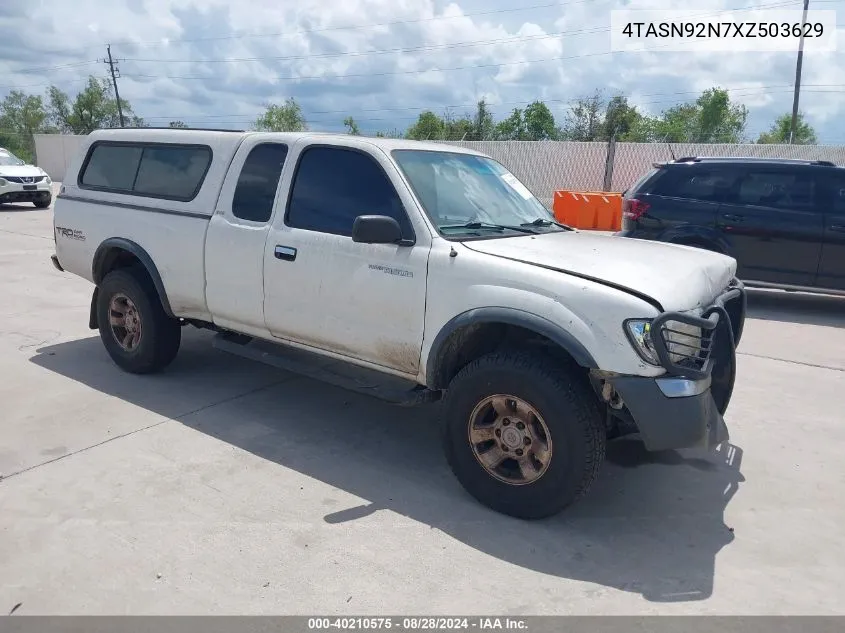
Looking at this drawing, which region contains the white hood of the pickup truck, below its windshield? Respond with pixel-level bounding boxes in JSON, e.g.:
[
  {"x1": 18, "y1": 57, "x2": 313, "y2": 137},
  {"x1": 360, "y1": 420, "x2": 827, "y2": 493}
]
[{"x1": 464, "y1": 231, "x2": 736, "y2": 312}]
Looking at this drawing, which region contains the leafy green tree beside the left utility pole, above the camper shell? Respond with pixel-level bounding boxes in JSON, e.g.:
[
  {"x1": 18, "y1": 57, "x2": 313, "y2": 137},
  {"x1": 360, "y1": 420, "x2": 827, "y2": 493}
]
[{"x1": 47, "y1": 75, "x2": 144, "y2": 134}]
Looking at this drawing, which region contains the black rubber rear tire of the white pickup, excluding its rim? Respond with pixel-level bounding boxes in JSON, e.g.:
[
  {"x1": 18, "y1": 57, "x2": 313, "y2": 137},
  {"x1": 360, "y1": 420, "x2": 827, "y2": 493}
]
[{"x1": 97, "y1": 267, "x2": 182, "y2": 374}]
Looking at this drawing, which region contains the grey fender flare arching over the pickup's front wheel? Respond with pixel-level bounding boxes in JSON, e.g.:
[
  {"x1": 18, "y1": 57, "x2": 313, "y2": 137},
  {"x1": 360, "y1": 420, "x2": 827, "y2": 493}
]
[{"x1": 426, "y1": 307, "x2": 598, "y2": 387}]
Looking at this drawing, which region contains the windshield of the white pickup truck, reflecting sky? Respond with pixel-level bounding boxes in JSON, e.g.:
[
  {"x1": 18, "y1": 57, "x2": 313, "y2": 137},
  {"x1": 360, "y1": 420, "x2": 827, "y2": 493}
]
[{"x1": 392, "y1": 150, "x2": 565, "y2": 237}]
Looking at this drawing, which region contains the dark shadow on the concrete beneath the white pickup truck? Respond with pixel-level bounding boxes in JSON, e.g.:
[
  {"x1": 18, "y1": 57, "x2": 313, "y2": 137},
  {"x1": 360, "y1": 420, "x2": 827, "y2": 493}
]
[{"x1": 31, "y1": 331, "x2": 744, "y2": 602}]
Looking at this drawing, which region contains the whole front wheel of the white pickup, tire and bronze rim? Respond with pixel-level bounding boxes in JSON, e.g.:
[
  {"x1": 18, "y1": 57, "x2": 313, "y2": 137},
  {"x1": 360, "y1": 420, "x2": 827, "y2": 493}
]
[{"x1": 443, "y1": 352, "x2": 606, "y2": 519}]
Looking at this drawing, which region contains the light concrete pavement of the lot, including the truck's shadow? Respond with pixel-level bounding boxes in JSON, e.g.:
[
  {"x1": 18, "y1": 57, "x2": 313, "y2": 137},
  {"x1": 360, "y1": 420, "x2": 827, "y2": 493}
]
[{"x1": 0, "y1": 193, "x2": 845, "y2": 615}]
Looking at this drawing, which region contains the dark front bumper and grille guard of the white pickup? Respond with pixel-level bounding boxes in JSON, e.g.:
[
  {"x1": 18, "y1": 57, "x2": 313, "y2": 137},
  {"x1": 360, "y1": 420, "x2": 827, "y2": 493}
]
[{"x1": 607, "y1": 280, "x2": 746, "y2": 451}]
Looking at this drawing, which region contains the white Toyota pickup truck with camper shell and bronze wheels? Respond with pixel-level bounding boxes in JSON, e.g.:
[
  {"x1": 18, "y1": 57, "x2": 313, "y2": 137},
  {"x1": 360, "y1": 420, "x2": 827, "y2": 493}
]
[{"x1": 53, "y1": 129, "x2": 745, "y2": 518}]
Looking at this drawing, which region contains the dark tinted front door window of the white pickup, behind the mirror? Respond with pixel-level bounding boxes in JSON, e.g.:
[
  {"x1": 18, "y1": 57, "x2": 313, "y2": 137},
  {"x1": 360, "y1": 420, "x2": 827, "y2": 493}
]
[{"x1": 286, "y1": 147, "x2": 413, "y2": 238}]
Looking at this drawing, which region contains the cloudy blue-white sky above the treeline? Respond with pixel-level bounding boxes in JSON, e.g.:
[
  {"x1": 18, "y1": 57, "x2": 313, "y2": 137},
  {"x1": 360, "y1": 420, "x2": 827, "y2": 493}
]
[{"x1": 0, "y1": 0, "x2": 845, "y2": 144}]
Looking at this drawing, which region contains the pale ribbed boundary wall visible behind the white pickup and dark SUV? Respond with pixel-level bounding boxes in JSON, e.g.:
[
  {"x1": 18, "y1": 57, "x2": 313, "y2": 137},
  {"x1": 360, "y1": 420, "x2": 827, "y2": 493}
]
[{"x1": 29, "y1": 134, "x2": 845, "y2": 202}]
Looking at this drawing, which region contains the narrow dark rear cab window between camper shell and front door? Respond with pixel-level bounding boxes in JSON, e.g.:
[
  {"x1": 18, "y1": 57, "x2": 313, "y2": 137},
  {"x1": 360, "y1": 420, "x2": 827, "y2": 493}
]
[{"x1": 232, "y1": 143, "x2": 288, "y2": 222}]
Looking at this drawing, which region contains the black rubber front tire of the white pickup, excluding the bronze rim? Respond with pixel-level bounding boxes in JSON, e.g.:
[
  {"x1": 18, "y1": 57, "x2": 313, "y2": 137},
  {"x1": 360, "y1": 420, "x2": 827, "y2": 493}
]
[{"x1": 442, "y1": 352, "x2": 607, "y2": 519}]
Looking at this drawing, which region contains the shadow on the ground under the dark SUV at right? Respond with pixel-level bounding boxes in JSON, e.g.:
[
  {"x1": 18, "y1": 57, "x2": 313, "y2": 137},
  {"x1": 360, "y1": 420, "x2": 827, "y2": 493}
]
[{"x1": 748, "y1": 288, "x2": 845, "y2": 327}]
